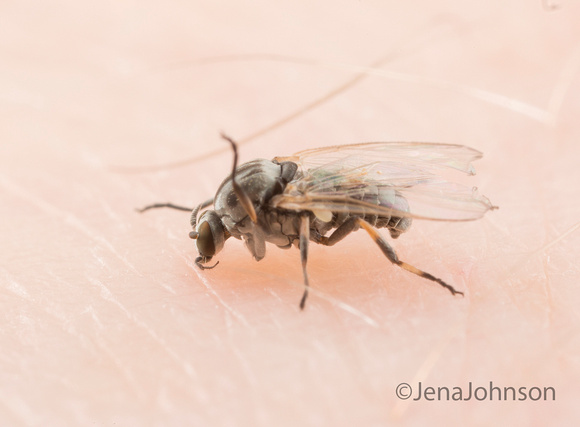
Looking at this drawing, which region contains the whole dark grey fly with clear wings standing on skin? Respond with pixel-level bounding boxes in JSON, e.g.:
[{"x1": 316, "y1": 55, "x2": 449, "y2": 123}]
[{"x1": 139, "y1": 134, "x2": 496, "y2": 309}]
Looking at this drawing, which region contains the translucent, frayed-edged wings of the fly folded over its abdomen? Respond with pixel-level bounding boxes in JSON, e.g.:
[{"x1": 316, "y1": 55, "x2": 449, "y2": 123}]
[{"x1": 271, "y1": 142, "x2": 494, "y2": 221}]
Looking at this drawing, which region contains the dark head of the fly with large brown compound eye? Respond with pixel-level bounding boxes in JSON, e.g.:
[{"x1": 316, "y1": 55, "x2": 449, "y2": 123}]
[{"x1": 189, "y1": 210, "x2": 229, "y2": 270}]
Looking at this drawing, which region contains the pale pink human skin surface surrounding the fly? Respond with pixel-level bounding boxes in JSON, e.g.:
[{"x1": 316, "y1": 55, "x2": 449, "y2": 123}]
[{"x1": 0, "y1": 0, "x2": 580, "y2": 426}]
